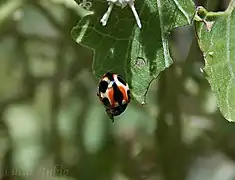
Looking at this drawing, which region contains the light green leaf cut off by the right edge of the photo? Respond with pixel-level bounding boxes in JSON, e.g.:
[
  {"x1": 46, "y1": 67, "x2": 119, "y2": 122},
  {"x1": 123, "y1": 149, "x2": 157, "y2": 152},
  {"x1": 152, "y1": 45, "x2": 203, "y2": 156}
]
[{"x1": 195, "y1": 0, "x2": 235, "y2": 121}]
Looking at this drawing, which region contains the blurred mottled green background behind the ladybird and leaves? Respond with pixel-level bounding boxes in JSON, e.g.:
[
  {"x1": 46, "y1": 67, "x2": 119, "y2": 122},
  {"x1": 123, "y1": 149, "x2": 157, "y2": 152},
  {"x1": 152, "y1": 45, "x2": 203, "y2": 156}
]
[{"x1": 0, "y1": 0, "x2": 235, "y2": 180}]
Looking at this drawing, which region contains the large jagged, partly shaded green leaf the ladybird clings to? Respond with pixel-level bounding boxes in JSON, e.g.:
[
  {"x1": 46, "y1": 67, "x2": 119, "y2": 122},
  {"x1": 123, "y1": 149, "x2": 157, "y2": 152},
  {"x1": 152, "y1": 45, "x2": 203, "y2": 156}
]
[{"x1": 72, "y1": 0, "x2": 195, "y2": 104}]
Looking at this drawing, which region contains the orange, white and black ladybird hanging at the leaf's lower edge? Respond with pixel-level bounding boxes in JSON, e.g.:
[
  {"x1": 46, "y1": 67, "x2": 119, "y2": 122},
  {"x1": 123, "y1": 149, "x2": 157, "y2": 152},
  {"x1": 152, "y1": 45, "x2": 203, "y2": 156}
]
[{"x1": 97, "y1": 72, "x2": 131, "y2": 122}]
